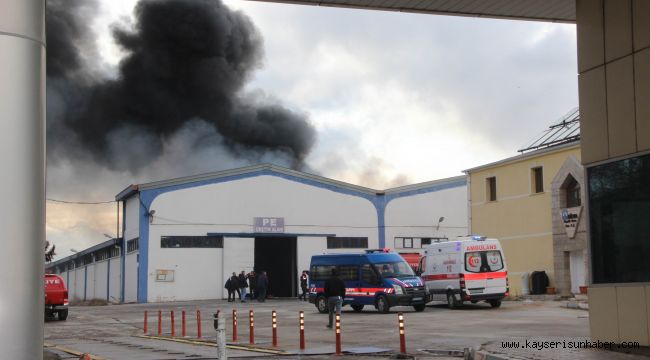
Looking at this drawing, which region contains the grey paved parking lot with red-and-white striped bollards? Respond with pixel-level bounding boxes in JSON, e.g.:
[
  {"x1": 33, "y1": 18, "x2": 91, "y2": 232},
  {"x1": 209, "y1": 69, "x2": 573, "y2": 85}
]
[{"x1": 45, "y1": 299, "x2": 629, "y2": 359}]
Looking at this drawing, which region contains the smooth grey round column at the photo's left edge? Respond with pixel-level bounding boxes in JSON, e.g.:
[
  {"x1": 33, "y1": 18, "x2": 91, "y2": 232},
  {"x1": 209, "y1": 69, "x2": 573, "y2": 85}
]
[{"x1": 0, "y1": 0, "x2": 45, "y2": 359}]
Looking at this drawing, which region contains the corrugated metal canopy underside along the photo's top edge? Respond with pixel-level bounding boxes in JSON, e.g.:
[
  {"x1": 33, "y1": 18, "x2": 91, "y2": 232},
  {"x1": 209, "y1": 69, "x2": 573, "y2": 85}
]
[{"x1": 251, "y1": 0, "x2": 576, "y2": 23}]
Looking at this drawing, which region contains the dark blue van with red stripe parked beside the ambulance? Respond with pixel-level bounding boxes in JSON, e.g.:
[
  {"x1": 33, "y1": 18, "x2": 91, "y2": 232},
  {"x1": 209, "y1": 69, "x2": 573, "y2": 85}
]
[{"x1": 309, "y1": 249, "x2": 428, "y2": 313}]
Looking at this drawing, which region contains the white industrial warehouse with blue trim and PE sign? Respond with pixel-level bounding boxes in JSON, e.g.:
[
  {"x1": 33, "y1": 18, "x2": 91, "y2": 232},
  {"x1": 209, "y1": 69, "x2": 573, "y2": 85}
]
[{"x1": 47, "y1": 165, "x2": 468, "y2": 302}]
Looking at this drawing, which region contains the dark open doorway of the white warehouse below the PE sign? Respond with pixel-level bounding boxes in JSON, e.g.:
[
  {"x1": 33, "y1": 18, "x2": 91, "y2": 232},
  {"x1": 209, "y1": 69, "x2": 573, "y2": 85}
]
[{"x1": 254, "y1": 236, "x2": 298, "y2": 297}]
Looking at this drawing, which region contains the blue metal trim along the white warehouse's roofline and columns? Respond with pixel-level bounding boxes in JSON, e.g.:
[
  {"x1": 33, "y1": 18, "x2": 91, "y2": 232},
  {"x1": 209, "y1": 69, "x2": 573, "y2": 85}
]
[{"x1": 138, "y1": 169, "x2": 467, "y2": 303}]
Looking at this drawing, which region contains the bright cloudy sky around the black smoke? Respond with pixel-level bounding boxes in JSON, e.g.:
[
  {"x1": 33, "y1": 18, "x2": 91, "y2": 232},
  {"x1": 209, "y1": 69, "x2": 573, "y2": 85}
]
[{"x1": 46, "y1": 0, "x2": 578, "y2": 260}]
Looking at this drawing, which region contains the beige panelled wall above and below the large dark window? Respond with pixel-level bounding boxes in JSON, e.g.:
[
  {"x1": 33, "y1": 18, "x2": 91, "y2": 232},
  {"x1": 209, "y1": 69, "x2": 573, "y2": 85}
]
[{"x1": 576, "y1": 0, "x2": 650, "y2": 346}]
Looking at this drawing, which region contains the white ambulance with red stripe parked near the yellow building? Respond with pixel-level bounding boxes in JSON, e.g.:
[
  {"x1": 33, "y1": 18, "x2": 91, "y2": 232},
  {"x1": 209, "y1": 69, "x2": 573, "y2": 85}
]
[{"x1": 417, "y1": 236, "x2": 508, "y2": 309}]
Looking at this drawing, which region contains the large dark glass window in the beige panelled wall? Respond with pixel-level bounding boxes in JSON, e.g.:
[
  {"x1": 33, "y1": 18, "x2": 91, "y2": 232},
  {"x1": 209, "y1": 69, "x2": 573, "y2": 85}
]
[{"x1": 587, "y1": 155, "x2": 650, "y2": 284}]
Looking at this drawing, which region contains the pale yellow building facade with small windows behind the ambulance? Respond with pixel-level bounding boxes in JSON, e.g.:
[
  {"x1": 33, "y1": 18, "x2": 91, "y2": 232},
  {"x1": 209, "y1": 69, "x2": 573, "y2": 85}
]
[{"x1": 466, "y1": 141, "x2": 587, "y2": 296}]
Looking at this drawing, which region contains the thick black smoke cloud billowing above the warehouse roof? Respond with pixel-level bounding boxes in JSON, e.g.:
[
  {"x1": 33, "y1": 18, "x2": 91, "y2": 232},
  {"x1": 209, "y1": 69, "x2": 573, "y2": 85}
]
[{"x1": 46, "y1": 0, "x2": 316, "y2": 175}]
